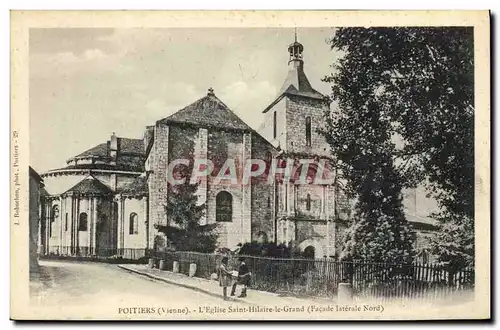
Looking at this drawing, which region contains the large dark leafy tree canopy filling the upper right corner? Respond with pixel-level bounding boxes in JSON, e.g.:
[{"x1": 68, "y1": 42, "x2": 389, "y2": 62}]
[{"x1": 324, "y1": 27, "x2": 474, "y2": 264}]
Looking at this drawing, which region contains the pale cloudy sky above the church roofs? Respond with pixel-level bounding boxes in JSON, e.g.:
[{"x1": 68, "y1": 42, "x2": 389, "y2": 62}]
[{"x1": 29, "y1": 28, "x2": 337, "y2": 173}]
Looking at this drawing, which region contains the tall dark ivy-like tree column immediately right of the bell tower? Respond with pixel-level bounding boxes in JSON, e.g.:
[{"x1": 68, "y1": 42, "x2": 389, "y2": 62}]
[{"x1": 322, "y1": 97, "x2": 415, "y2": 264}]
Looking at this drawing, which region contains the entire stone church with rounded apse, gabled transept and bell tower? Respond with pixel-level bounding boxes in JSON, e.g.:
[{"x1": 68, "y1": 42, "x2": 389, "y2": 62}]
[{"x1": 39, "y1": 36, "x2": 433, "y2": 258}]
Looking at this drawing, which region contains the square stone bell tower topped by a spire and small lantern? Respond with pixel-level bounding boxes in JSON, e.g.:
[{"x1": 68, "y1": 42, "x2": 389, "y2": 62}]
[{"x1": 260, "y1": 31, "x2": 335, "y2": 256}]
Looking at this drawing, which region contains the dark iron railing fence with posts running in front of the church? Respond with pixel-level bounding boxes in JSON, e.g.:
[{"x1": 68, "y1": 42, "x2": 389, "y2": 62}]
[{"x1": 151, "y1": 252, "x2": 474, "y2": 299}]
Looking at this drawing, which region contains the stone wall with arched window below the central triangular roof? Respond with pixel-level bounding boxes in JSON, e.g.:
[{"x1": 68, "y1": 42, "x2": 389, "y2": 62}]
[{"x1": 146, "y1": 126, "x2": 272, "y2": 247}]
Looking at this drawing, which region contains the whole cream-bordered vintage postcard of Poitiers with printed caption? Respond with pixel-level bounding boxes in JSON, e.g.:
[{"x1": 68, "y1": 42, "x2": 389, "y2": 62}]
[{"x1": 10, "y1": 11, "x2": 491, "y2": 321}]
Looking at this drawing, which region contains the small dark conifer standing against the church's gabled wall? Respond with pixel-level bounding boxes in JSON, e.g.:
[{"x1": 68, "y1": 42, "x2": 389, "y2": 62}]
[{"x1": 155, "y1": 166, "x2": 217, "y2": 252}]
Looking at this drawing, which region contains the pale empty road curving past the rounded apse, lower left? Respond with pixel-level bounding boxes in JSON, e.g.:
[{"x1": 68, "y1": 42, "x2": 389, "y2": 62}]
[{"x1": 31, "y1": 261, "x2": 247, "y2": 318}]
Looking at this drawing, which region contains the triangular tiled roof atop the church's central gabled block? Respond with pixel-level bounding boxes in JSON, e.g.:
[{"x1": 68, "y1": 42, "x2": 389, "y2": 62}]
[{"x1": 159, "y1": 90, "x2": 252, "y2": 131}]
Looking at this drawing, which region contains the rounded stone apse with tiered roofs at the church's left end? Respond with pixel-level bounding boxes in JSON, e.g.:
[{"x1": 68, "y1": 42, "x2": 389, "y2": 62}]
[{"x1": 40, "y1": 133, "x2": 147, "y2": 256}]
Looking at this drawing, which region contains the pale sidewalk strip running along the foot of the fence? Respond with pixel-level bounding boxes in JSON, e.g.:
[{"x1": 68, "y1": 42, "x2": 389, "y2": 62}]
[{"x1": 118, "y1": 264, "x2": 335, "y2": 306}]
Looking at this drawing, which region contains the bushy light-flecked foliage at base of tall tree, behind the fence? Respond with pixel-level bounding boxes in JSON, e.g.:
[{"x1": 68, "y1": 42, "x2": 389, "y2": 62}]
[{"x1": 343, "y1": 157, "x2": 415, "y2": 264}]
